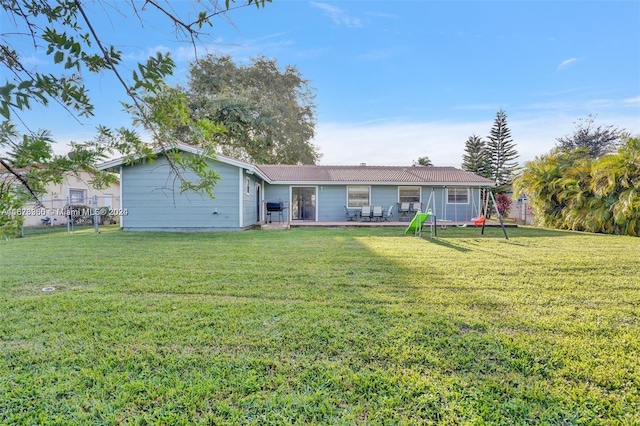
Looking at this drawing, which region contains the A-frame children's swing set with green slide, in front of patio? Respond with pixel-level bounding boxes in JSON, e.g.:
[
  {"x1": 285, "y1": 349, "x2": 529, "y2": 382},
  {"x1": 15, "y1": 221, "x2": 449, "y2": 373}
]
[{"x1": 405, "y1": 187, "x2": 509, "y2": 240}]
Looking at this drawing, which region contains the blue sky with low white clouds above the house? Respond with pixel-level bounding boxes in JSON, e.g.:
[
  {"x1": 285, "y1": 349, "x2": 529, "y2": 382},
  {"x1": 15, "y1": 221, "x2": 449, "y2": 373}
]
[{"x1": 2, "y1": 0, "x2": 640, "y2": 166}]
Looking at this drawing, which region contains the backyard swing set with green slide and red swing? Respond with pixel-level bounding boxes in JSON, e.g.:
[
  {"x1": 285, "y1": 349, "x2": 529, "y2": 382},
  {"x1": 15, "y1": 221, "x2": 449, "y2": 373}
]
[{"x1": 405, "y1": 188, "x2": 509, "y2": 240}]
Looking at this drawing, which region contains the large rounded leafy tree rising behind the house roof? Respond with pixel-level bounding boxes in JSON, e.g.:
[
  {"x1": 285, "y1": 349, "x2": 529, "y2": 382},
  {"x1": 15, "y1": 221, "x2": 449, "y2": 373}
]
[{"x1": 182, "y1": 55, "x2": 320, "y2": 164}]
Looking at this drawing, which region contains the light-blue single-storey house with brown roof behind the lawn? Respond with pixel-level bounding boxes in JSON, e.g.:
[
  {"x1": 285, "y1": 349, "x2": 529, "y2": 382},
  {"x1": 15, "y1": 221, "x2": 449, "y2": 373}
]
[{"x1": 99, "y1": 143, "x2": 493, "y2": 231}]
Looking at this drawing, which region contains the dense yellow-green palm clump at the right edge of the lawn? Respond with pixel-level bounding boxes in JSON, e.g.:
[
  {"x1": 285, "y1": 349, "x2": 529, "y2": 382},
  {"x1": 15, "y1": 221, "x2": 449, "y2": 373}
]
[{"x1": 514, "y1": 138, "x2": 640, "y2": 236}]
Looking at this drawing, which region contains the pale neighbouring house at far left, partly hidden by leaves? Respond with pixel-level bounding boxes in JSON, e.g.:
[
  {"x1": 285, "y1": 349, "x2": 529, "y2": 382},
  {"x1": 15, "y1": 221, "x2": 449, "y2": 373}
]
[{"x1": 24, "y1": 172, "x2": 120, "y2": 226}]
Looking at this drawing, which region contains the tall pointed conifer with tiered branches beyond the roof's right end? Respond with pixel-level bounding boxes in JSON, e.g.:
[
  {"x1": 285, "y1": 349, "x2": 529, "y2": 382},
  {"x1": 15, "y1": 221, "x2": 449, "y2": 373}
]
[{"x1": 487, "y1": 108, "x2": 518, "y2": 187}]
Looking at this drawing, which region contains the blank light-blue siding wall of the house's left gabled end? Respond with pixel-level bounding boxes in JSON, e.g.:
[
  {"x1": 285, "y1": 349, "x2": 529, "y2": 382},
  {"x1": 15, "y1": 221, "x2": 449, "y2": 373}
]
[{"x1": 121, "y1": 158, "x2": 253, "y2": 231}]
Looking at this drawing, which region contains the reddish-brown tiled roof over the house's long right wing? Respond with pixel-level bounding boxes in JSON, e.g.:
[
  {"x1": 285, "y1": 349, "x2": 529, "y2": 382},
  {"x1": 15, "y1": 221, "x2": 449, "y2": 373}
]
[{"x1": 256, "y1": 164, "x2": 493, "y2": 186}]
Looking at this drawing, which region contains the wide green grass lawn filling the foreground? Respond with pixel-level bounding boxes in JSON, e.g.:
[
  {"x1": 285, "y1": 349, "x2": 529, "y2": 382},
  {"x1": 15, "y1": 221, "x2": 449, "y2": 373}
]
[{"x1": 0, "y1": 228, "x2": 640, "y2": 425}]
